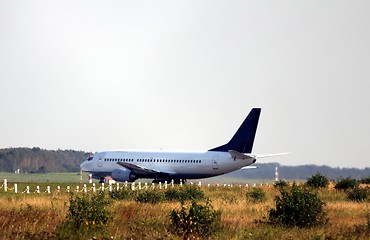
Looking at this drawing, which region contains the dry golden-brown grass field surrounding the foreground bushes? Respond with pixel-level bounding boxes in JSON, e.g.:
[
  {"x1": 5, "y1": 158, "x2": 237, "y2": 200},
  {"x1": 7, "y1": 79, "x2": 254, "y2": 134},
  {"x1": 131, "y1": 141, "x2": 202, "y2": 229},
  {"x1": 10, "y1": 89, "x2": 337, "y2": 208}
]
[{"x1": 0, "y1": 180, "x2": 370, "y2": 239}]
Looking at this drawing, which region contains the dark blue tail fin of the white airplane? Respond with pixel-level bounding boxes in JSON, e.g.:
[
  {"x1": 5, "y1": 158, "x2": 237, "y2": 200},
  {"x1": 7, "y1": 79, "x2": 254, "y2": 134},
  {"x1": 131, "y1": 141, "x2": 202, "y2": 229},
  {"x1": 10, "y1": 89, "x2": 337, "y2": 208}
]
[{"x1": 209, "y1": 108, "x2": 261, "y2": 153}]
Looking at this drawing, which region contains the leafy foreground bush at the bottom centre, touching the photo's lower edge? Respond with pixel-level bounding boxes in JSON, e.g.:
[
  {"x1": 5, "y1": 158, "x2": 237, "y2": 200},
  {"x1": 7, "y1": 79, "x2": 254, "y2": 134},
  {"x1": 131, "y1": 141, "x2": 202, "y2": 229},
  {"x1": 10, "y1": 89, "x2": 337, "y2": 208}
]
[{"x1": 170, "y1": 200, "x2": 221, "y2": 239}]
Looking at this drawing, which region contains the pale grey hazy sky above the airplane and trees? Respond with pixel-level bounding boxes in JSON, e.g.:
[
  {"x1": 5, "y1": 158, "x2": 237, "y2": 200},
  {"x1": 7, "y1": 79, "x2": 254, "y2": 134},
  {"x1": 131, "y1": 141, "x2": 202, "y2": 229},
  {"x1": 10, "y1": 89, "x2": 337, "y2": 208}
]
[{"x1": 0, "y1": 0, "x2": 370, "y2": 168}]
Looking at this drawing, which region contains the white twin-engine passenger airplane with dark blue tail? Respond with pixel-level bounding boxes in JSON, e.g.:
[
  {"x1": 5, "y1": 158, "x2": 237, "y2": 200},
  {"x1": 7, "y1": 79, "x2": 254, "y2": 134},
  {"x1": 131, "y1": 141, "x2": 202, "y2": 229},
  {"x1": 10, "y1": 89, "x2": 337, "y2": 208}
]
[{"x1": 80, "y1": 108, "x2": 289, "y2": 183}]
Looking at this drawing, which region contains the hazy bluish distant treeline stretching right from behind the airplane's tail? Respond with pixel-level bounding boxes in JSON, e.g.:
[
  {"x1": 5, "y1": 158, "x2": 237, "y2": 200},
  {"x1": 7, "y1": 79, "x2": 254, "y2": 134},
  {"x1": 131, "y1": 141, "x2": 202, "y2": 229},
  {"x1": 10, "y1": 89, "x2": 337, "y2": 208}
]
[{"x1": 227, "y1": 163, "x2": 370, "y2": 180}]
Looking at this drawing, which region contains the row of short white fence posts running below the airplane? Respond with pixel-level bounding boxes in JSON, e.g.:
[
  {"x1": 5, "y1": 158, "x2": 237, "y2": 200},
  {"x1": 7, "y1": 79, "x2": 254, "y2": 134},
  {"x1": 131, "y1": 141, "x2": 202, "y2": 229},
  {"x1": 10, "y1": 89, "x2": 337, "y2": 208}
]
[{"x1": 0, "y1": 179, "x2": 272, "y2": 194}]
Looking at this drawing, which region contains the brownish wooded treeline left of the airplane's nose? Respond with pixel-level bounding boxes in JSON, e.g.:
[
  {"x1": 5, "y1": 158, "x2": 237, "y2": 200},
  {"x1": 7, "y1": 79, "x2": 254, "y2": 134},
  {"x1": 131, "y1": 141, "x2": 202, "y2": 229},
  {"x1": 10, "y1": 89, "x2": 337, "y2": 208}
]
[{"x1": 0, "y1": 147, "x2": 91, "y2": 173}]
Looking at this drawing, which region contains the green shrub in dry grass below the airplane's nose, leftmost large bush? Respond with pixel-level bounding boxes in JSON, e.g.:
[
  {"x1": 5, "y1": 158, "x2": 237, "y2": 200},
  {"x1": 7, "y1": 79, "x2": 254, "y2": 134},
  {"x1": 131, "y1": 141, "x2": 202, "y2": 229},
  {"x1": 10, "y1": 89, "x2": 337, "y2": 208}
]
[{"x1": 67, "y1": 192, "x2": 111, "y2": 229}]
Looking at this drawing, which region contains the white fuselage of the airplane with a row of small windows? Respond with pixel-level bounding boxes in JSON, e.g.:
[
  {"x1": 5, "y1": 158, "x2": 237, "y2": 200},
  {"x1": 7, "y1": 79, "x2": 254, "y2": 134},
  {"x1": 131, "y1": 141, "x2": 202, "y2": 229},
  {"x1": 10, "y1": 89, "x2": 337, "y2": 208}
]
[{"x1": 81, "y1": 151, "x2": 255, "y2": 179}]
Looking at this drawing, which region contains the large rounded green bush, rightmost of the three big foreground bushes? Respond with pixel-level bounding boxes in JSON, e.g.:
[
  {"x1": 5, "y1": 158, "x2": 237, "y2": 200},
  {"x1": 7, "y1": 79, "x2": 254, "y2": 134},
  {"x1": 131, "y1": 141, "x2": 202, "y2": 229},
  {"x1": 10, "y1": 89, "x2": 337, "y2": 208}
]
[{"x1": 269, "y1": 183, "x2": 326, "y2": 227}]
